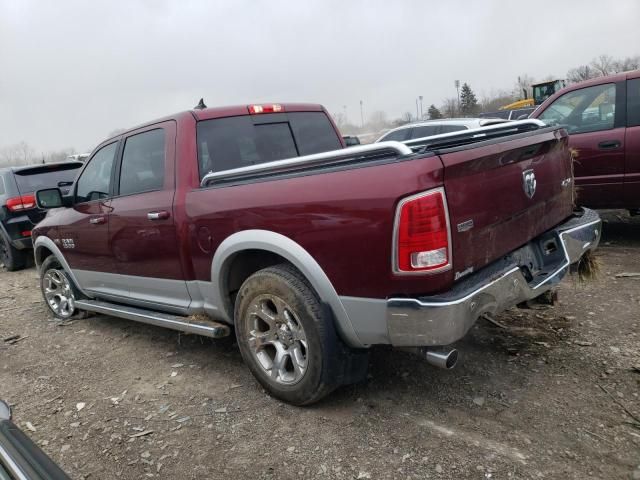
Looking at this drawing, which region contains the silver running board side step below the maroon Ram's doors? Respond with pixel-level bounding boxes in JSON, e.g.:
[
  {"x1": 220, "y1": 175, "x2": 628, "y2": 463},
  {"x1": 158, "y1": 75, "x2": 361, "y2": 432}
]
[{"x1": 76, "y1": 300, "x2": 231, "y2": 338}]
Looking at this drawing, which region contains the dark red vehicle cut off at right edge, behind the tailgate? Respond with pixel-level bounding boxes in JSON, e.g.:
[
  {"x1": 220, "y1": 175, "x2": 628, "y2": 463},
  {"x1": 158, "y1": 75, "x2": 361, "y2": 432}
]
[{"x1": 532, "y1": 71, "x2": 640, "y2": 213}]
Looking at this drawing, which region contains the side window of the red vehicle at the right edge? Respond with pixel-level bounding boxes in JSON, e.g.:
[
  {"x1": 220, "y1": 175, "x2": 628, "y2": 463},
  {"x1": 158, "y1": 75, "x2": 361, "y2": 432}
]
[{"x1": 538, "y1": 83, "x2": 616, "y2": 133}]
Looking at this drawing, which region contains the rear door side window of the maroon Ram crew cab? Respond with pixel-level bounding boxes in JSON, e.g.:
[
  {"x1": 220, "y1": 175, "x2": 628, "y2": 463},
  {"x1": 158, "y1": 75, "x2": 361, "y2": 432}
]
[{"x1": 119, "y1": 128, "x2": 165, "y2": 195}]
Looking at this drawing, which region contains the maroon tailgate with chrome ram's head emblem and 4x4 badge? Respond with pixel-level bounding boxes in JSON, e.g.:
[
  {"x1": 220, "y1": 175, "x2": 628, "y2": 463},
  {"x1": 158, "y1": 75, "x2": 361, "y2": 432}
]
[{"x1": 439, "y1": 129, "x2": 573, "y2": 280}]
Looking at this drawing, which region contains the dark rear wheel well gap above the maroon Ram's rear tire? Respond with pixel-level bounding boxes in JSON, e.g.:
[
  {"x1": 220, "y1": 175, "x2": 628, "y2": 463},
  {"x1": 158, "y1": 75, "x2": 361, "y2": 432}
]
[{"x1": 222, "y1": 250, "x2": 295, "y2": 320}]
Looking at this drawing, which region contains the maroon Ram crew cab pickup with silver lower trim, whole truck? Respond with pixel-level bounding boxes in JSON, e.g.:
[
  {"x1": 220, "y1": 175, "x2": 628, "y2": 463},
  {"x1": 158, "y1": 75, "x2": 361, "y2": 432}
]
[{"x1": 33, "y1": 104, "x2": 600, "y2": 404}]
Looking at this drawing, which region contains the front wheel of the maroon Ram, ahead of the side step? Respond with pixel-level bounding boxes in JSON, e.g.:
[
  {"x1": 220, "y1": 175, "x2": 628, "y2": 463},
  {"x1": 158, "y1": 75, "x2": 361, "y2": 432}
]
[{"x1": 40, "y1": 255, "x2": 86, "y2": 320}]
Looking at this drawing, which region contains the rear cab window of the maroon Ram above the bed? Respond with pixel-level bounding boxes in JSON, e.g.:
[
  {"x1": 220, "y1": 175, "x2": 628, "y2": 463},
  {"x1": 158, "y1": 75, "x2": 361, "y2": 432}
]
[{"x1": 197, "y1": 112, "x2": 342, "y2": 180}]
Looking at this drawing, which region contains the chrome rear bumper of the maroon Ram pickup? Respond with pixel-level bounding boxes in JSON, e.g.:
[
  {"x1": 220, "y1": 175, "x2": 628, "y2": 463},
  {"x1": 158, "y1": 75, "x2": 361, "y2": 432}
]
[{"x1": 386, "y1": 209, "x2": 602, "y2": 346}]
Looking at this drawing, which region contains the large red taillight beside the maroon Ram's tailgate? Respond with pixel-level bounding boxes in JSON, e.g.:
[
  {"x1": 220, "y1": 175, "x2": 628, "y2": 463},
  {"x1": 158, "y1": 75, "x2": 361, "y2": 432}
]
[{"x1": 393, "y1": 188, "x2": 451, "y2": 273}]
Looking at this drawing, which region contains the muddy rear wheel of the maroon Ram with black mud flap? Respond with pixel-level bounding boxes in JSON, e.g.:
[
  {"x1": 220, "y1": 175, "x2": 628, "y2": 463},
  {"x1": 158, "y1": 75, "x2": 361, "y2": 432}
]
[{"x1": 235, "y1": 264, "x2": 368, "y2": 405}]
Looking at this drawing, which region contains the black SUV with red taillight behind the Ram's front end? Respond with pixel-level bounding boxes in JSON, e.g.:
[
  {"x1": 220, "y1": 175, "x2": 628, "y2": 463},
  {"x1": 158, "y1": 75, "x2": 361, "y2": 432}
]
[{"x1": 0, "y1": 162, "x2": 82, "y2": 271}]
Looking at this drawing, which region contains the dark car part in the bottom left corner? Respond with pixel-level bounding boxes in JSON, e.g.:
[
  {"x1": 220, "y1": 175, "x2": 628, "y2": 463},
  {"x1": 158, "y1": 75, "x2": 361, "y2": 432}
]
[{"x1": 0, "y1": 400, "x2": 69, "y2": 480}]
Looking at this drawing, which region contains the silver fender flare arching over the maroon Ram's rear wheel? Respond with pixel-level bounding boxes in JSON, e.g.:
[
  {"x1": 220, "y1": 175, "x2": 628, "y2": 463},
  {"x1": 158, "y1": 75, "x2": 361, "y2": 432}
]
[{"x1": 211, "y1": 230, "x2": 366, "y2": 348}]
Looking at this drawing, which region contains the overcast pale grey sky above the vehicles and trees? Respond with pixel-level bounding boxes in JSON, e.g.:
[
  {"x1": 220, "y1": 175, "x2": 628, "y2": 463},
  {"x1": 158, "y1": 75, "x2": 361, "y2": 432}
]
[{"x1": 0, "y1": 0, "x2": 640, "y2": 152}]
